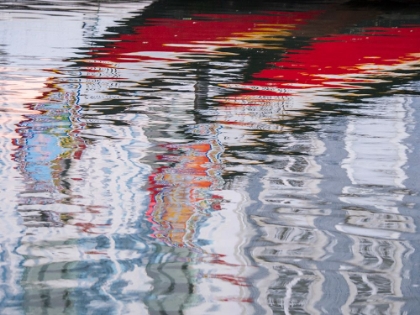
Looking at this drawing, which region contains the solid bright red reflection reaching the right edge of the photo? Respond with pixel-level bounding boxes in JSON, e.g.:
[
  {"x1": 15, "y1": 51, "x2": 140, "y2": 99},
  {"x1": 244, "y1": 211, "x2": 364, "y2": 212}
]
[{"x1": 224, "y1": 27, "x2": 420, "y2": 104}]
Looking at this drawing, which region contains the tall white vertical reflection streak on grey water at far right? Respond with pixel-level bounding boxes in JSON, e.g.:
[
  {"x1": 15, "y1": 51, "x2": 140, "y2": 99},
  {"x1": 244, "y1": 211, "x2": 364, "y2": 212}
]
[{"x1": 336, "y1": 97, "x2": 415, "y2": 314}]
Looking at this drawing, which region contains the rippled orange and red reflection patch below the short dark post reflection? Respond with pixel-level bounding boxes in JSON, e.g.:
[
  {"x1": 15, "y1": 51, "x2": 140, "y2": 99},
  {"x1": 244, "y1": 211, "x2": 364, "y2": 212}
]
[{"x1": 147, "y1": 126, "x2": 223, "y2": 248}]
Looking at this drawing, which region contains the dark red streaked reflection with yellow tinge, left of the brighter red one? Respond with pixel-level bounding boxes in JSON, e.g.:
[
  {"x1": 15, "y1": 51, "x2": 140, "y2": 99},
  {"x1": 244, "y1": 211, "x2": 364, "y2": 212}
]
[{"x1": 92, "y1": 12, "x2": 318, "y2": 62}]
